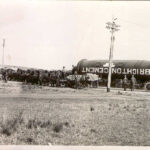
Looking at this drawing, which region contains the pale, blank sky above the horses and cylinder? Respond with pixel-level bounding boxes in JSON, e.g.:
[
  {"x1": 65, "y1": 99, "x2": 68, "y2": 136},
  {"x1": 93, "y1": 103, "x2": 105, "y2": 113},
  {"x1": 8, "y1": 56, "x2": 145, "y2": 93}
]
[{"x1": 0, "y1": 0, "x2": 150, "y2": 70}]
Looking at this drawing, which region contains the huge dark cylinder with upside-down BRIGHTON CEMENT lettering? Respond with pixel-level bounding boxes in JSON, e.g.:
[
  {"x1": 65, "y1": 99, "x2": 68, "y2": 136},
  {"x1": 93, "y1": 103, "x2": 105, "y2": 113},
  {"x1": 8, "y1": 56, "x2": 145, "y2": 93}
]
[{"x1": 77, "y1": 59, "x2": 150, "y2": 82}]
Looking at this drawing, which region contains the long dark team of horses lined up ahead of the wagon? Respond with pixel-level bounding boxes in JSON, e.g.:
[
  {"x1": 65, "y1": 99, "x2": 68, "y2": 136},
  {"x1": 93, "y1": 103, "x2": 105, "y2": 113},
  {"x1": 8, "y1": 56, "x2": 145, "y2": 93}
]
[{"x1": 1, "y1": 69, "x2": 67, "y2": 86}]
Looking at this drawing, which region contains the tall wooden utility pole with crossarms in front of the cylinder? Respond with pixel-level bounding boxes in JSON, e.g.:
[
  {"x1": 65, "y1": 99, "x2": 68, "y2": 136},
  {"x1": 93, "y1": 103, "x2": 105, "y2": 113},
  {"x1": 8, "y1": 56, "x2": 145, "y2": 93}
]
[{"x1": 106, "y1": 18, "x2": 120, "y2": 92}]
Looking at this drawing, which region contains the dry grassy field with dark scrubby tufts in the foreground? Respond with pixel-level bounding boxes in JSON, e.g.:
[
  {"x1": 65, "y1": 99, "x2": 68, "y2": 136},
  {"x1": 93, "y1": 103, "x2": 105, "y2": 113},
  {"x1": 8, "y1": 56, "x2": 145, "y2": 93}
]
[{"x1": 0, "y1": 83, "x2": 150, "y2": 146}]
